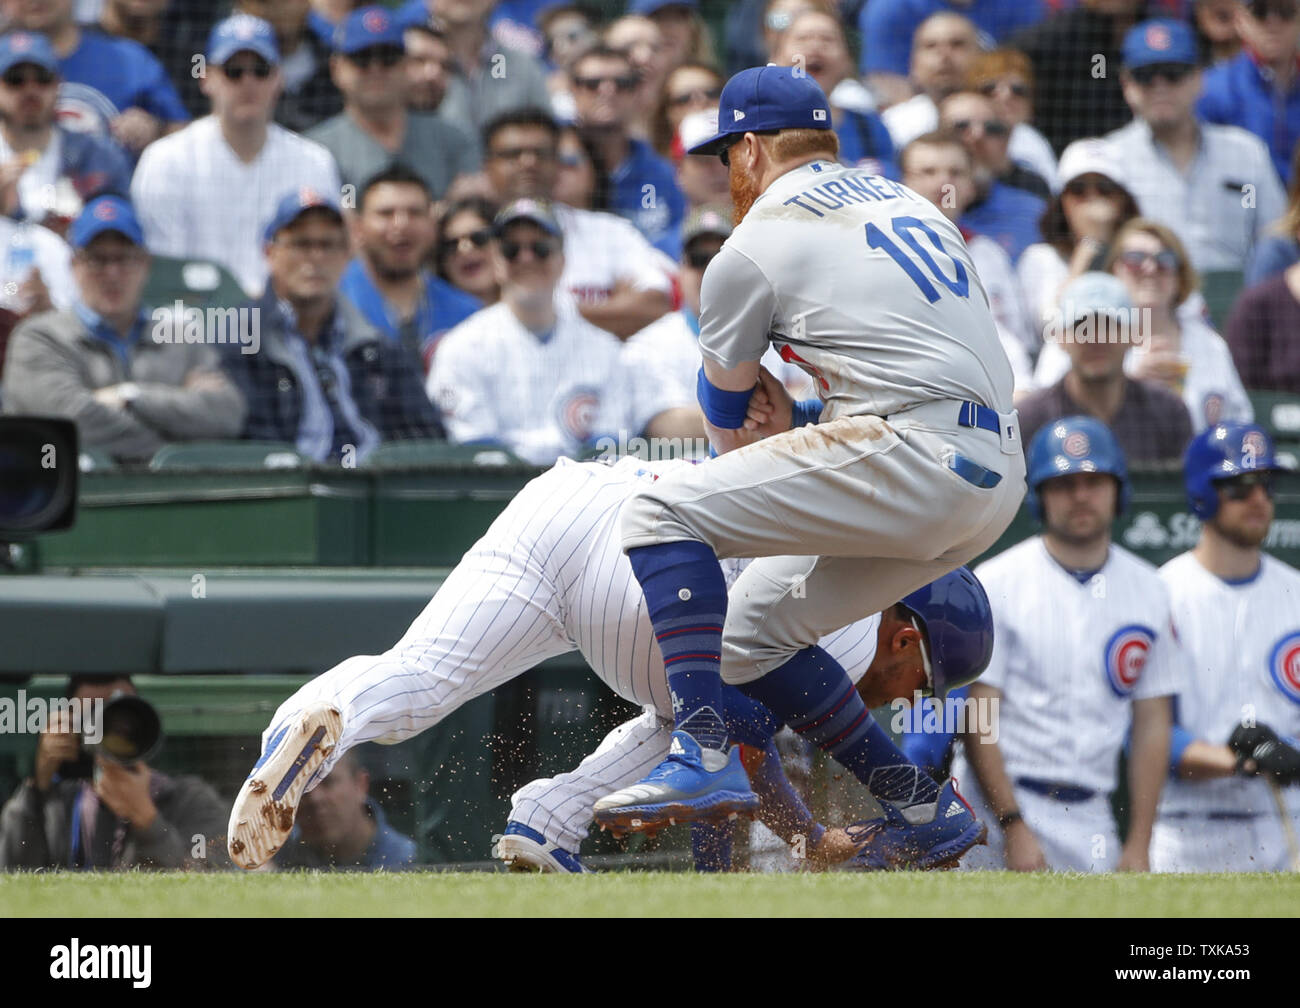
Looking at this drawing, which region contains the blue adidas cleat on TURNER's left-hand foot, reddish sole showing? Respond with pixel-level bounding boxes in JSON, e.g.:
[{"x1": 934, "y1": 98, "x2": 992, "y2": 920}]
[{"x1": 595, "y1": 731, "x2": 758, "y2": 834}]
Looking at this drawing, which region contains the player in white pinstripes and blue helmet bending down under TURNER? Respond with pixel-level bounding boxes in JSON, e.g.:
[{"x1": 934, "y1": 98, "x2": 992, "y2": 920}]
[{"x1": 228, "y1": 458, "x2": 988, "y2": 868}]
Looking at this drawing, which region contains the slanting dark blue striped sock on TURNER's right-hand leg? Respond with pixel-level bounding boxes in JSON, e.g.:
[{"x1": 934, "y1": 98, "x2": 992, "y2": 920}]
[{"x1": 740, "y1": 646, "x2": 939, "y2": 805}]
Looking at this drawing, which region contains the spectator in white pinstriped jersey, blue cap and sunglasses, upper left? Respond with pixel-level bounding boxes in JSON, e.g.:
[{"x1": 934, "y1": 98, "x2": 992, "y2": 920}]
[{"x1": 131, "y1": 14, "x2": 339, "y2": 297}]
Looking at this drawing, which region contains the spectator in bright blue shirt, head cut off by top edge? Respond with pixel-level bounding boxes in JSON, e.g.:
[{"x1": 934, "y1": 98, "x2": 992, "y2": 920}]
[{"x1": 858, "y1": 0, "x2": 1057, "y2": 104}]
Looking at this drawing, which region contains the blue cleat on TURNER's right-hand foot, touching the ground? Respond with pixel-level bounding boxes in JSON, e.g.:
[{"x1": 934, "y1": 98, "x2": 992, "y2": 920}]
[{"x1": 845, "y1": 780, "x2": 988, "y2": 871}]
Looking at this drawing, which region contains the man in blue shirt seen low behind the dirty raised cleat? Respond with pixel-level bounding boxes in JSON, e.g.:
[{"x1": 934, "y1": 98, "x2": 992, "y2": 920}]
[{"x1": 274, "y1": 749, "x2": 416, "y2": 871}]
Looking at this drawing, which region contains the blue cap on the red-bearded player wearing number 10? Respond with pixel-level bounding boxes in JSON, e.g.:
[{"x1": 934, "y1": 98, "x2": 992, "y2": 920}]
[{"x1": 686, "y1": 65, "x2": 831, "y2": 153}]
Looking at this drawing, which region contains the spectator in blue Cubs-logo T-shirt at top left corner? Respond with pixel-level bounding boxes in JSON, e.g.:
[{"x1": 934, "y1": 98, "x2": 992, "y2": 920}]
[{"x1": 10, "y1": 0, "x2": 190, "y2": 156}]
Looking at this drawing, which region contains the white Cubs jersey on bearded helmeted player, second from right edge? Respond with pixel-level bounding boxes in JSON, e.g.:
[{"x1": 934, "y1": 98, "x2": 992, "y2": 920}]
[{"x1": 954, "y1": 536, "x2": 1183, "y2": 791}]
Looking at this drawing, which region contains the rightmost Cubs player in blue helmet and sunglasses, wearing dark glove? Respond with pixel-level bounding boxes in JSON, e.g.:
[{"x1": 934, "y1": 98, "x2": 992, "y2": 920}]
[{"x1": 1151, "y1": 423, "x2": 1300, "y2": 871}]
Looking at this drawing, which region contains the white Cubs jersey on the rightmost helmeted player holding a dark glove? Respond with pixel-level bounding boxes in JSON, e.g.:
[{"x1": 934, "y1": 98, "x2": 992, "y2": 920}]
[{"x1": 1160, "y1": 553, "x2": 1300, "y2": 816}]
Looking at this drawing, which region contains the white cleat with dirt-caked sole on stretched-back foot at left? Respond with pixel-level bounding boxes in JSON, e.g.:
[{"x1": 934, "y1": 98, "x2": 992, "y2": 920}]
[{"x1": 226, "y1": 704, "x2": 343, "y2": 870}]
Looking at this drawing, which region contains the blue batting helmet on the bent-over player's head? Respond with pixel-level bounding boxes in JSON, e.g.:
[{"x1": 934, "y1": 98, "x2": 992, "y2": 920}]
[{"x1": 901, "y1": 567, "x2": 993, "y2": 697}]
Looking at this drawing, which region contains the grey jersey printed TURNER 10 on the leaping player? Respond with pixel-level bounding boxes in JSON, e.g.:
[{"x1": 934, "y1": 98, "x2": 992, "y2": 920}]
[{"x1": 699, "y1": 161, "x2": 1011, "y2": 420}]
